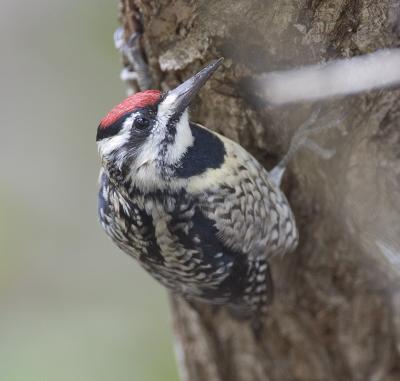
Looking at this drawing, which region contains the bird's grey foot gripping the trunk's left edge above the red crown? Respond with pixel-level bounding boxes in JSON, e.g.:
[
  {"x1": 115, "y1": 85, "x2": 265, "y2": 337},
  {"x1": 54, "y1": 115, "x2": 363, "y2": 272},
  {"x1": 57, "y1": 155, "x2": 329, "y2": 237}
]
[{"x1": 114, "y1": 27, "x2": 153, "y2": 91}]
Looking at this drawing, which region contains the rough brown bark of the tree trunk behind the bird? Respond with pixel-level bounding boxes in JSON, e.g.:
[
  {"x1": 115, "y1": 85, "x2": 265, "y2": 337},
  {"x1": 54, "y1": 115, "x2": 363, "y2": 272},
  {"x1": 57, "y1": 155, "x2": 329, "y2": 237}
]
[{"x1": 121, "y1": 0, "x2": 400, "y2": 381}]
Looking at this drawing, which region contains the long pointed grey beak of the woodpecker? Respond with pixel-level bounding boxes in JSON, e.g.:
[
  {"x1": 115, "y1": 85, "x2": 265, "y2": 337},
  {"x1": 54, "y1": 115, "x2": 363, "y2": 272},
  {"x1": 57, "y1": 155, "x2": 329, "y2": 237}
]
[{"x1": 164, "y1": 58, "x2": 224, "y2": 114}]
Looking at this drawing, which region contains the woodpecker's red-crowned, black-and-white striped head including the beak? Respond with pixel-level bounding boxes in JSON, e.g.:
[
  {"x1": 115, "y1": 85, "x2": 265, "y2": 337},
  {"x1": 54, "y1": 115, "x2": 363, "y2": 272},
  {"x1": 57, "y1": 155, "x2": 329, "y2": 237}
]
[{"x1": 96, "y1": 59, "x2": 222, "y2": 189}]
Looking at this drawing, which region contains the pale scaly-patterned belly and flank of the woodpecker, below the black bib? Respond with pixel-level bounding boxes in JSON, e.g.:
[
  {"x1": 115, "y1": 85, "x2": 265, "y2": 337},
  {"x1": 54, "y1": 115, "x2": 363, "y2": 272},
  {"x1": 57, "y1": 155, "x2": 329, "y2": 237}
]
[{"x1": 198, "y1": 138, "x2": 298, "y2": 258}]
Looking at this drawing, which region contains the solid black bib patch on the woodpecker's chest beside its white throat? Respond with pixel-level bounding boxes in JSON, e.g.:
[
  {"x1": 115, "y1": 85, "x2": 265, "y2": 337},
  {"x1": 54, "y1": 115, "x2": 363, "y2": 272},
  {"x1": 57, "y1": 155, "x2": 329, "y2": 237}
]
[{"x1": 175, "y1": 123, "x2": 225, "y2": 178}]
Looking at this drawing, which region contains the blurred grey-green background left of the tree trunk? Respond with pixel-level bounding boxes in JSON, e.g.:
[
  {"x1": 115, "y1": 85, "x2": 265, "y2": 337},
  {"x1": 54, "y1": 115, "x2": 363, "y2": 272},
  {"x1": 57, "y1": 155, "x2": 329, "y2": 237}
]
[{"x1": 0, "y1": 0, "x2": 178, "y2": 381}]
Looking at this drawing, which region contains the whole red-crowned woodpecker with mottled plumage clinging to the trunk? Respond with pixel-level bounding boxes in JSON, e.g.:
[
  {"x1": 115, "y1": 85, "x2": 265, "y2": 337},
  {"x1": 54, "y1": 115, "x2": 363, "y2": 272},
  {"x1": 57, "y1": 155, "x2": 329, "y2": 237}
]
[{"x1": 96, "y1": 59, "x2": 298, "y2": 314}]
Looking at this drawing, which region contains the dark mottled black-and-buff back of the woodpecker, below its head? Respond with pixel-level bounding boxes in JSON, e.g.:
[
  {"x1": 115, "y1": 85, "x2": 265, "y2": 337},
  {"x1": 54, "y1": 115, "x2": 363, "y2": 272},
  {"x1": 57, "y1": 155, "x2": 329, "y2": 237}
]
[{"x1": 99, "y1": 173, "x2": 238, "y2": 298}]
